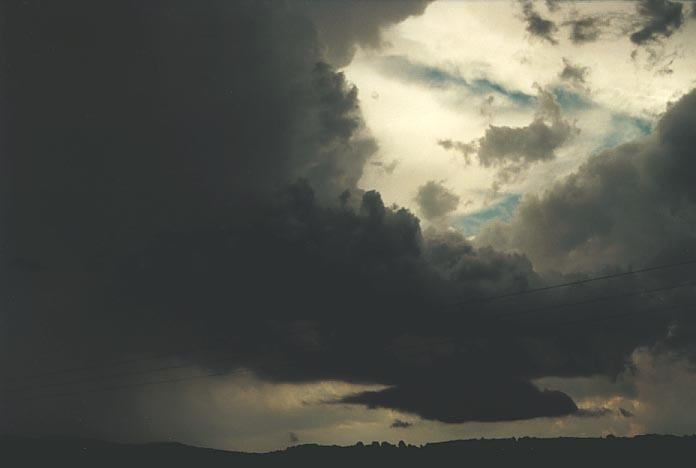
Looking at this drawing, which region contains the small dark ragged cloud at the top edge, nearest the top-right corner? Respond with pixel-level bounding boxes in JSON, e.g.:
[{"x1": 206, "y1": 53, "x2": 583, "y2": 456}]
[{"x1": 631, "y1": 0, "x2": 684, "y2": 45}]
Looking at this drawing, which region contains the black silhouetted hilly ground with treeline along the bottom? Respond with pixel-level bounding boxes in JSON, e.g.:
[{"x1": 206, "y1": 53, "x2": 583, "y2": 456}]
[{"x1": 0, "y1": 435, "x2": 696, "y2": 468}]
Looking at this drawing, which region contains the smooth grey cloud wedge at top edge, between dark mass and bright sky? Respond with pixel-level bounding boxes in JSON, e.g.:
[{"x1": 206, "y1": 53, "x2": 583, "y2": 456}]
[{"x1": 305, "y1": 0, "x2": 432, "y2": 67}]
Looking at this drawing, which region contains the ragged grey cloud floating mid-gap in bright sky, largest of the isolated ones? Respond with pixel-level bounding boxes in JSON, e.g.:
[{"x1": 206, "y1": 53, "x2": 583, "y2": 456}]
[{"x1": 438, "y1": 88, "x2": 578, "y2": 186}]
